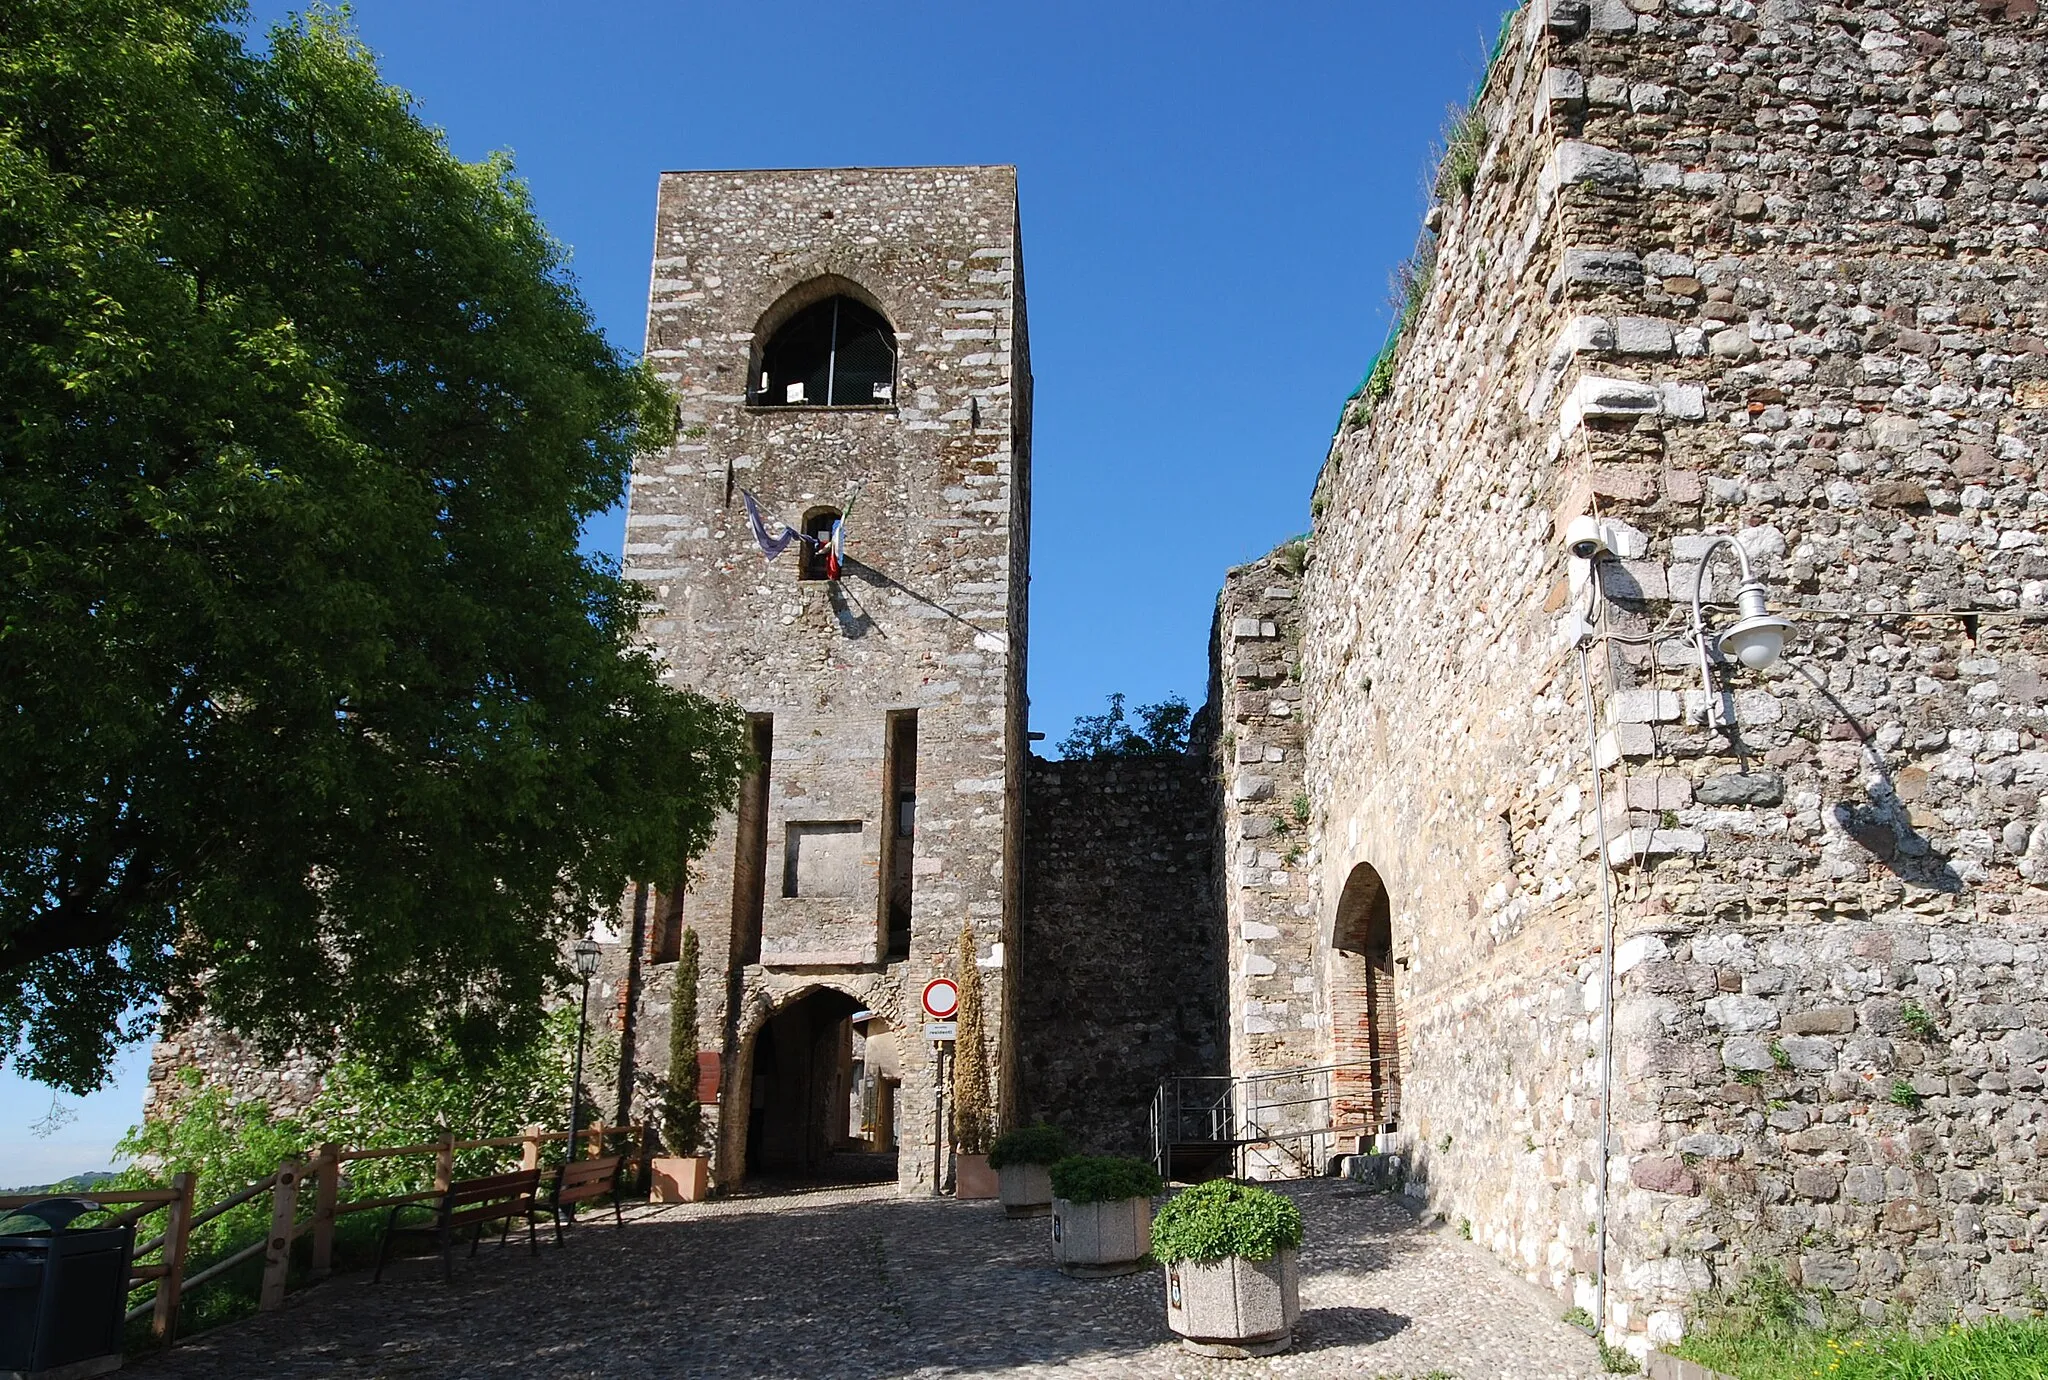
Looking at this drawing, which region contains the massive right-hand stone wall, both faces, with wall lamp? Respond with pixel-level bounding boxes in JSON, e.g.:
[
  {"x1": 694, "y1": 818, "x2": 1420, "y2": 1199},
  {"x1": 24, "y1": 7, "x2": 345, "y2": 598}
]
[{"x1": 1300, "y1": 0, "x2": 2048, "y2": 1345}]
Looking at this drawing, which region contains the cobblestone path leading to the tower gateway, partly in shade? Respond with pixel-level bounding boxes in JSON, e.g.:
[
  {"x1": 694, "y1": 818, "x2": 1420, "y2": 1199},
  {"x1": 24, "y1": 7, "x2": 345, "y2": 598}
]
[{"x1": 131, "y1": 1181, "x2": 1602, "y2": 1380}]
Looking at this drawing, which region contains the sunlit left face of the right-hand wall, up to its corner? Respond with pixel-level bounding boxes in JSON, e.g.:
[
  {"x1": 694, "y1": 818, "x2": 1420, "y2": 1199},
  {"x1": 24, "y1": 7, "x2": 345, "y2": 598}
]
[{"x1": 1296, "y1": 8, "x2": 1599, "y2": 1334}]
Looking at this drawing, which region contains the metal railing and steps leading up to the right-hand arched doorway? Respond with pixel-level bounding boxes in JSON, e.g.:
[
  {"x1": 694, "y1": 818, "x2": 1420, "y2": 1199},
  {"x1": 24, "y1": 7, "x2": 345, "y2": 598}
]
[{"x1": 1151, "y1": 1059, "x2": 1401, "y2": 1183}]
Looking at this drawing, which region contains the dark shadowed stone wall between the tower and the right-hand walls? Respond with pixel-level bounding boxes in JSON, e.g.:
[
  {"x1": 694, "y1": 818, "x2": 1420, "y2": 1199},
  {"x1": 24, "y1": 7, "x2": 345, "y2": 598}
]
[{"x1": 1016, "y1": 751, "x2": 1227, "y2": 1159}]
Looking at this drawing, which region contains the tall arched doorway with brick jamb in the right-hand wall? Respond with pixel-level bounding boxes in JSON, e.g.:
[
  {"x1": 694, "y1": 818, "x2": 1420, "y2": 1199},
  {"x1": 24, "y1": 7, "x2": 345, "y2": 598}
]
[{"x1": 1329, "y1": 862, "x2": 1401, "y2": 1132}]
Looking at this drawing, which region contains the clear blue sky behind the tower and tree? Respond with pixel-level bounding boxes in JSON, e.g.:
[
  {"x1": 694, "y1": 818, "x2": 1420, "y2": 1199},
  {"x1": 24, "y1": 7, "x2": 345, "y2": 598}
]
[{"x1": 0, "y1": 0, "x2": 1507, "y2": 1185}]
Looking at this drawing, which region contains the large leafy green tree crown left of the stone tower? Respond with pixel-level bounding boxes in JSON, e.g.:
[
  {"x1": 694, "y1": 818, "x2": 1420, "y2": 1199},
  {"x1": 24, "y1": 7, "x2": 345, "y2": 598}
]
[{"x1": 0, "y1": 0, "x2": 745, "y2": 1091}]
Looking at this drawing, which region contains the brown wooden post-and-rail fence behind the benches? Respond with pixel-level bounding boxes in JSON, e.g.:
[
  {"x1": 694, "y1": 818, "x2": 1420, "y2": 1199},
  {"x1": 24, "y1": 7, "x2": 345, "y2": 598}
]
[{"x1": 0, "y1": 1126, "x2": 645, "y2": 1347}]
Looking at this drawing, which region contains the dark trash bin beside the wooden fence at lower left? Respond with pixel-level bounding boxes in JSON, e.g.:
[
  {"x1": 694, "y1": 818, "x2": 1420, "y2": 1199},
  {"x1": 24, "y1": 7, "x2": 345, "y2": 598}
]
[{"x1": 0, "y1": 1206, "x2": 135, "y2": 1380}]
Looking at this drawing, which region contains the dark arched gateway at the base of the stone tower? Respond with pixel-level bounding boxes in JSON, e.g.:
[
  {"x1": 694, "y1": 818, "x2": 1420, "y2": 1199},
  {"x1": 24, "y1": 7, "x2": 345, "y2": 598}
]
[{"x1": 745, "y1": 987, "x2": 895, "y2": 1181}]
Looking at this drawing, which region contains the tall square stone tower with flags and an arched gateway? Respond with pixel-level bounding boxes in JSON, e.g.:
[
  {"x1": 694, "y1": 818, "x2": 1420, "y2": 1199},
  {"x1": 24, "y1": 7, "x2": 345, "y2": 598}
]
[{"x1": 625, "y1": 168, "x2": 1030, "y2": 1190}]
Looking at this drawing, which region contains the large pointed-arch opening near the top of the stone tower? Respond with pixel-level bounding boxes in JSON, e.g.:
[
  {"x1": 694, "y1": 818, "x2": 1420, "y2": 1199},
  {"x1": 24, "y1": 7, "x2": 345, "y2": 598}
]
[{"x1": 748, "y1": 274, "x2": 897, "y2": 407}]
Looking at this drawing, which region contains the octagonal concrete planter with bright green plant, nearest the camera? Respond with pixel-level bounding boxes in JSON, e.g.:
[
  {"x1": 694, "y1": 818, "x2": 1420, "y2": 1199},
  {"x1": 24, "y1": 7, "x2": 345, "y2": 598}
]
[{"x1": 1151, "y1": 1179, "x2": 1300, "y2": 1360}]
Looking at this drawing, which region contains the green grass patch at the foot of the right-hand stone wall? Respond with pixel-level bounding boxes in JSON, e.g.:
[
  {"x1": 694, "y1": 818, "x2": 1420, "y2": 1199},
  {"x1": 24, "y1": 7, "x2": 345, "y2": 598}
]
[{"x1": 1677, "y1": 1269, "x2": 2048, "y2": 1380}]
